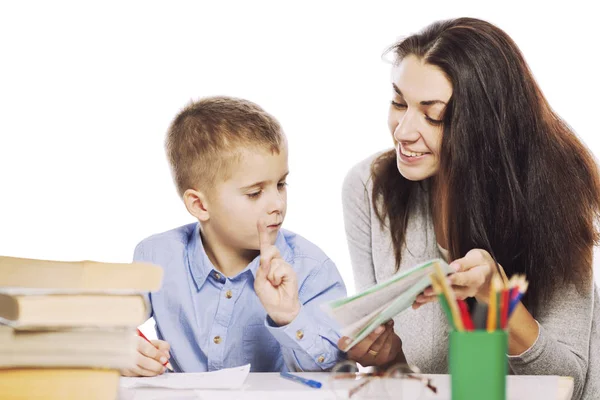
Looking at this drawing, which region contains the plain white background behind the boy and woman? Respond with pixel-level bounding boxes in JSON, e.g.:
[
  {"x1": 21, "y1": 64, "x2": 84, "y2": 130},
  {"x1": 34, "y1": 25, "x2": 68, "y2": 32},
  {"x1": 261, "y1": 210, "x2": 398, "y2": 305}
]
[{"x1": 0, "y1": 0, "x2": 600, "y2": 338}]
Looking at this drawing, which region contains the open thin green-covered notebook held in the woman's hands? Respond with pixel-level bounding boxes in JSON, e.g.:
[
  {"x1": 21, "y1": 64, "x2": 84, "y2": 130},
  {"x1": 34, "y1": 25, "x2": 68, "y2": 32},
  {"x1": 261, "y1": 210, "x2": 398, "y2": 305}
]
[{"x1": 323, "y1": 258, "x2": 452, "y2": 351}]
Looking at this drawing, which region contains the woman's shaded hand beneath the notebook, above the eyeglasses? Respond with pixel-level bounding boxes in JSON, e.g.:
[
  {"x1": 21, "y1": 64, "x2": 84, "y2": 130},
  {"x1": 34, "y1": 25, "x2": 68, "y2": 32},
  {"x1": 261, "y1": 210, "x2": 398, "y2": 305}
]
[{"x1": 338, "y1": 320, "x2": 405, "y2": 367}]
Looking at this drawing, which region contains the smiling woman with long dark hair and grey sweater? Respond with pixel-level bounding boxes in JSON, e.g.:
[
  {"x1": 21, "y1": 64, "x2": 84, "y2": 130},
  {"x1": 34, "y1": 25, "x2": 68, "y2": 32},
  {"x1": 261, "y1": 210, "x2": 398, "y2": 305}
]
[{"x1": 338, "y1": 18, "x2": 600, "y2": 399}]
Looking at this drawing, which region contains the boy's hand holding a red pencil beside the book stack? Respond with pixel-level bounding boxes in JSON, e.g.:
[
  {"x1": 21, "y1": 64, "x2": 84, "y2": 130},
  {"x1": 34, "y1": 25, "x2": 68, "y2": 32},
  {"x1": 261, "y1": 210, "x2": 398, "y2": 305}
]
[{"x1": 121, "y1": 336, "x2": 171, "y2": 376}]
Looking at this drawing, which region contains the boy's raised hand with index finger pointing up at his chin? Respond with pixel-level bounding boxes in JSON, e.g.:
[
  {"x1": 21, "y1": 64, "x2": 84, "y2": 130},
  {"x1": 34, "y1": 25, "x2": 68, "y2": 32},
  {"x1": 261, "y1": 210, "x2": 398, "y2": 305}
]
[{"x1": 254, "y1": 221, "x2": 300, "y2": 326}]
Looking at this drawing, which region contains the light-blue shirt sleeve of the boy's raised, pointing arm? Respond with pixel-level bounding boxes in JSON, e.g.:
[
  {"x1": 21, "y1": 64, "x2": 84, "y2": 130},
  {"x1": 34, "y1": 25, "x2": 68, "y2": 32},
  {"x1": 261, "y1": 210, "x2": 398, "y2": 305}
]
[{"x1": 265, "y1": 259, "x2": 346, "y2": 371}]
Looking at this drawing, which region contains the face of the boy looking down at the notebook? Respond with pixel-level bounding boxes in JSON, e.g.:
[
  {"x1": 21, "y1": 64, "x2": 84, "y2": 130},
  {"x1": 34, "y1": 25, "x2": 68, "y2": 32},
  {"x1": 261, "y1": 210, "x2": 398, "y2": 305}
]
[{"x1": 208, "y1": 145, "x2": 288, "y2": 250}]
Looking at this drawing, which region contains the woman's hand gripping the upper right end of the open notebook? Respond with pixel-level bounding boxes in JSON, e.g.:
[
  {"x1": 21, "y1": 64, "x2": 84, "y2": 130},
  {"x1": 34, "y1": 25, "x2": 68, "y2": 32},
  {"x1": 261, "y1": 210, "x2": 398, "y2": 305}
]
[{"x1": 412, "y1": 249, "x2": 502, "y2": 310}]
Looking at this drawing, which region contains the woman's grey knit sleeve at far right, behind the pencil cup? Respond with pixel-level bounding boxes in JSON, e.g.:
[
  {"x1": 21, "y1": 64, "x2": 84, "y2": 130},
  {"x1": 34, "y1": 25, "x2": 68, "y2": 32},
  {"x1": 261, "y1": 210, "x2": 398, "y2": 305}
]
[{"x1": 508, "y1": 282, "x2": 598, "y2": 399}]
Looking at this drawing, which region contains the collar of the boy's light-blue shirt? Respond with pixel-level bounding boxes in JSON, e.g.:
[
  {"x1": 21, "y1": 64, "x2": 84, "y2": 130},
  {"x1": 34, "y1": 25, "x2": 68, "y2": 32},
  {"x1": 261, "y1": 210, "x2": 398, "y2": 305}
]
[{"x1": 187, "y1": 223, "x2": 293, "y2": 290}]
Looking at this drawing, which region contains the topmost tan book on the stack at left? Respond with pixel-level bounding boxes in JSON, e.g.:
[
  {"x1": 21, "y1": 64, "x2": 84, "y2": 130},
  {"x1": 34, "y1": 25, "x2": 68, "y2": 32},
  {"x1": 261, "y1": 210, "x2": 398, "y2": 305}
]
[{"x1": 0, "y1": 256, "x2": 163, "y2": 292}]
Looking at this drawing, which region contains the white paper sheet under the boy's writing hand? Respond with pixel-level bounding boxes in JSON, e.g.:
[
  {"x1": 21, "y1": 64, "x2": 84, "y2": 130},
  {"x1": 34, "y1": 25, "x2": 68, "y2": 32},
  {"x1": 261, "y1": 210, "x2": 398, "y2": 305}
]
[{"x1": 120, "y1": 364, "x2": 250, "y2": 389}]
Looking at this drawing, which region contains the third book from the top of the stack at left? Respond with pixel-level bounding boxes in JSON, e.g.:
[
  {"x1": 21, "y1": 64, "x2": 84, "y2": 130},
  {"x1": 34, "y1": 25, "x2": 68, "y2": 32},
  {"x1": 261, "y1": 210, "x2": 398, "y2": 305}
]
[{"x1": 0, "y1": 325, "x2": 137, "y2": 368}]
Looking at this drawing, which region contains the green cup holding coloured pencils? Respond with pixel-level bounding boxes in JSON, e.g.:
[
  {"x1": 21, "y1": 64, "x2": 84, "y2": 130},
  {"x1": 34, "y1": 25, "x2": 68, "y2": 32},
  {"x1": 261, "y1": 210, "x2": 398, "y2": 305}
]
[{"x1": 448, "y1": 330, "x2": 508, "y2": 400}]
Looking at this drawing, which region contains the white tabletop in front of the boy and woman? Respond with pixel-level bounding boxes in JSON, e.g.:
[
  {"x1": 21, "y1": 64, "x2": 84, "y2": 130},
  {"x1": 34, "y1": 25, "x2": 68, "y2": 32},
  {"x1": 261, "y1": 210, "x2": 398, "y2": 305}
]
[{"x1": 119, "y1": 372, "x2": 573, "y2": 400}]
